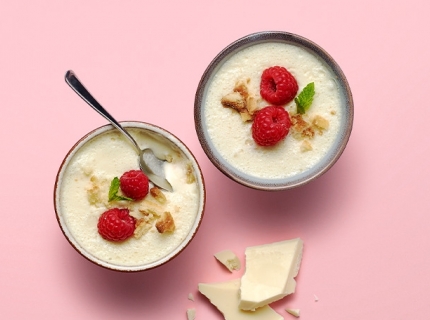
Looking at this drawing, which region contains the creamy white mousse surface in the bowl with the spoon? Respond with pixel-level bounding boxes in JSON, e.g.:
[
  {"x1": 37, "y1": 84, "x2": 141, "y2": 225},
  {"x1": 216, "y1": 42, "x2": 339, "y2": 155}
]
[{"x1": 56, "y1": 124, "x2": 204, "y2": 269}]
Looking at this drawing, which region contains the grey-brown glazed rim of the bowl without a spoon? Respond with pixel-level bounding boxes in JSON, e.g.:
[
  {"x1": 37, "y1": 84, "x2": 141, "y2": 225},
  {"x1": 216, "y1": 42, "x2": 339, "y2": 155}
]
[{"x1": 194, "y1": 31, "x2": 354, "y2": 191}]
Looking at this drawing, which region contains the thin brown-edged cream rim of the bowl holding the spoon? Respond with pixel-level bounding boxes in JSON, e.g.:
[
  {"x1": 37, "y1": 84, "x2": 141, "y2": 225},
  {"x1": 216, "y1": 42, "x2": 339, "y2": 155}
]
[{"x1": 53, "y1": 121, "x2": 206, "y2": 273}]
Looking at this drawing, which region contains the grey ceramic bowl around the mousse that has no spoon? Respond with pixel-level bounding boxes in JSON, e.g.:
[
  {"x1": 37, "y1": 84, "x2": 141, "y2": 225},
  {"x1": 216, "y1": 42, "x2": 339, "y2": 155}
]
[{"x1": 194, "y1": 31, "x2": 354, "y2": 191}]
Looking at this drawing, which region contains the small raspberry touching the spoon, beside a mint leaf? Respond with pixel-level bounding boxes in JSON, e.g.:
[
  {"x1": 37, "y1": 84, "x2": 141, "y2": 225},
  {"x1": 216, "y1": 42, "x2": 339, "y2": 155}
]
[{"x1": 119, "y1": 170, "x2": 149, "y2": 201}]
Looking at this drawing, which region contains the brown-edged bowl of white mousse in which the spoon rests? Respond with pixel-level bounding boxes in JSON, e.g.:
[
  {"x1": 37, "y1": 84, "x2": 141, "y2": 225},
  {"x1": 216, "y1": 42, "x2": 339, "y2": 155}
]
[{"x1": 54, "y1": 122, "x2": 206, "y2": 272}]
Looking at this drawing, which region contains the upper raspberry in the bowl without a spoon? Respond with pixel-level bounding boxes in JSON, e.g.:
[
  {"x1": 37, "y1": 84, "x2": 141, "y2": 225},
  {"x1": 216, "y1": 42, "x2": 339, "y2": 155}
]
[{"x1": 260, "y1": 66, "x2": 299, "y2": 105}]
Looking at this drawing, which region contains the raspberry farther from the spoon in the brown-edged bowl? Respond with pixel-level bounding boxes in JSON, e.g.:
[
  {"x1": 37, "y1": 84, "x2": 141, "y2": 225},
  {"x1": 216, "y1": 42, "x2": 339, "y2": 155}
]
[{"x1": 97, "y1": 208, "x2": 136, "y2": 241}]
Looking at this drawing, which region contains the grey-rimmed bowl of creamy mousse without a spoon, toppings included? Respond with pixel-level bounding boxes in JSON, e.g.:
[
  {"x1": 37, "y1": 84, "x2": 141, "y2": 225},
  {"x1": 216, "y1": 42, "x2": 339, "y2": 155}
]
[{"x1": 194, "y1": 32, "x2": 353, "y2": 191}]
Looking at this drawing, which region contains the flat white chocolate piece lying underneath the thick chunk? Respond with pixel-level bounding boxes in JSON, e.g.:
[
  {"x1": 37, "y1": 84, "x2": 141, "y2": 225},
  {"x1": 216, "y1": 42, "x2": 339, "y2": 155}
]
[{"x1": 199, "y1": 279, "x2": 284, "y2": 320}]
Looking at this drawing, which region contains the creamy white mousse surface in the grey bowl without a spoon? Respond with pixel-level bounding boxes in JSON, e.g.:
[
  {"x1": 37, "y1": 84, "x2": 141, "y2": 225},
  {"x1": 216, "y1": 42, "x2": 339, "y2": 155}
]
[{"x1": 203, "y1": 42, "x2": 342, "y2": 179}]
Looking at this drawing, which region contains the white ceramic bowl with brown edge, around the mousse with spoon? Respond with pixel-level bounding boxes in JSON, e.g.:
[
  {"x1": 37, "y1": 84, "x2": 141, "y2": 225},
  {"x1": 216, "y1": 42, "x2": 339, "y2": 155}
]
[{"x1": 54, "y1": 122, "x2": 206, "y2": 272}]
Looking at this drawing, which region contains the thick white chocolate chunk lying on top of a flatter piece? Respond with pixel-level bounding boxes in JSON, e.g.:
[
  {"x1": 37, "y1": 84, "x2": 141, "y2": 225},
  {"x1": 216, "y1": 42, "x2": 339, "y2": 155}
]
[{"x1": 239, "y1": 238, "x2": 303, "y2": 310}]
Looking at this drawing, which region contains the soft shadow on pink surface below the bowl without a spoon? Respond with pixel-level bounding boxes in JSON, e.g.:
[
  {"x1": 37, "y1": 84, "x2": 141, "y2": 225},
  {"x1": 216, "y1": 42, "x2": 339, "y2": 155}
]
[{"x1": 204, "y1": 151, "x2": 359, "y2": 234}]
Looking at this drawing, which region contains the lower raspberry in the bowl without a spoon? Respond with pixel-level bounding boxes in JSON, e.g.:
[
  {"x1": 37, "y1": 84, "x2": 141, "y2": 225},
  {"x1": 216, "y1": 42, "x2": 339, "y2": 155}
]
[{"x1": 252, "y1": 106, "x2": 291, "y2": 146}]
